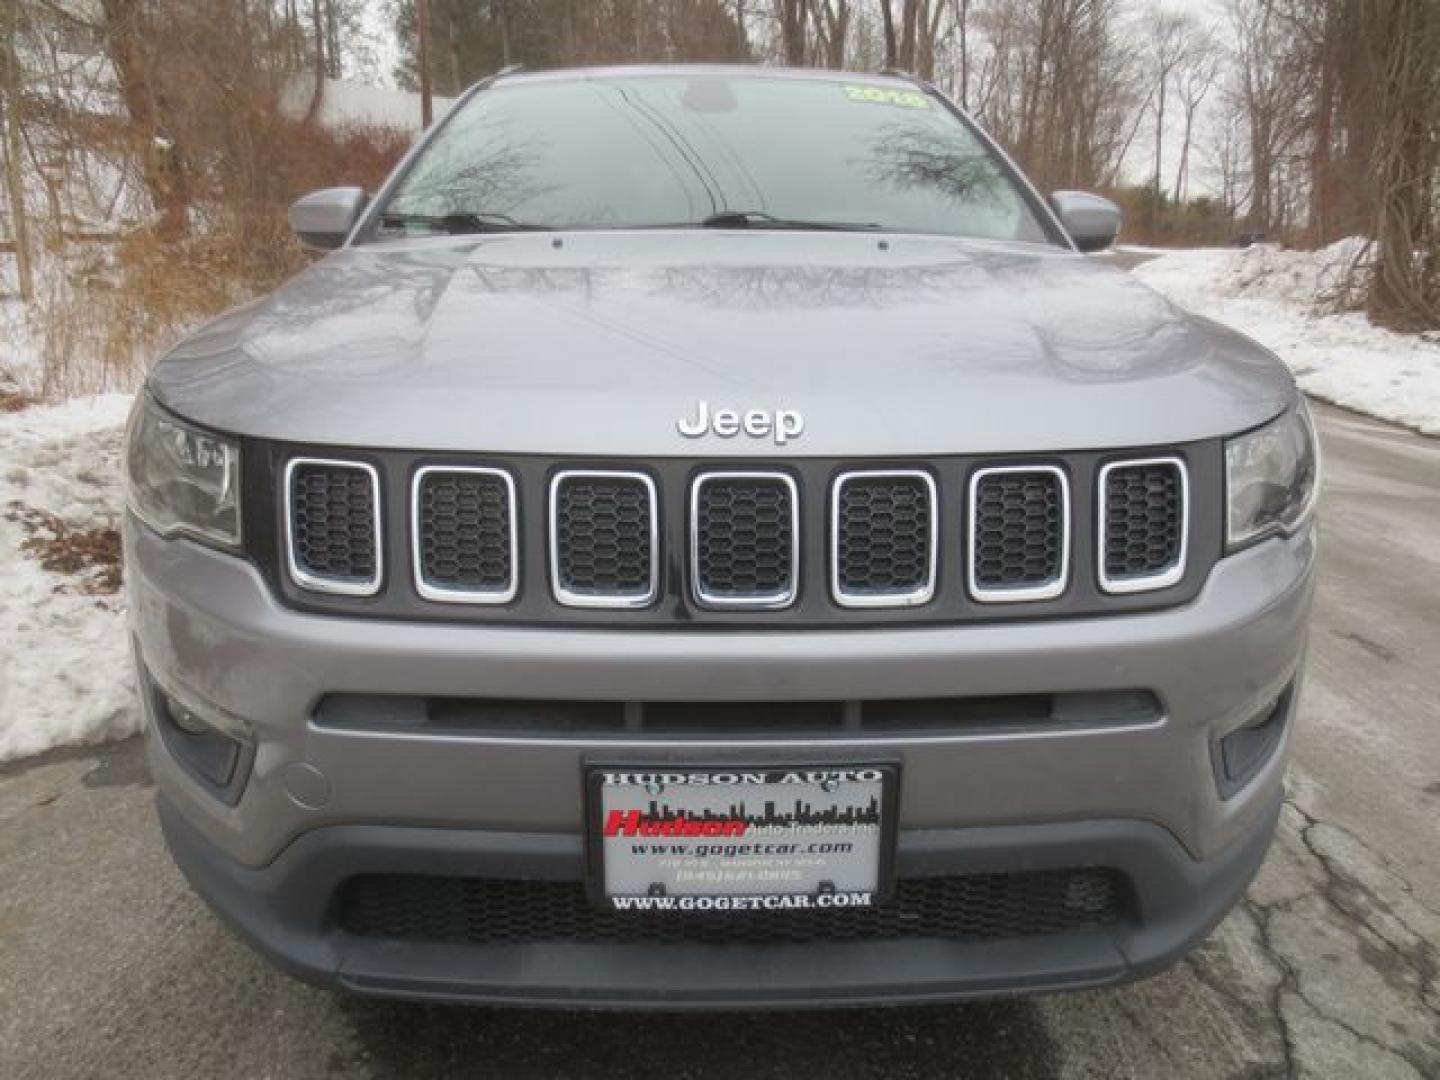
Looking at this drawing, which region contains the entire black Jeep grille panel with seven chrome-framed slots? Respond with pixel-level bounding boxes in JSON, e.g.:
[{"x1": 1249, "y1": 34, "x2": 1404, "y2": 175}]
[{"x1": 272, "y1": 439, "x2": 1203, "y2": 616}]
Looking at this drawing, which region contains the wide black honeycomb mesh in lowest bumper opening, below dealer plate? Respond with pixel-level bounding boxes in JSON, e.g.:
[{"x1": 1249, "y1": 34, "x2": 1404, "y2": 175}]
[{"x1": 338, "y1": 868, "x2": 1125, "y2": 945}]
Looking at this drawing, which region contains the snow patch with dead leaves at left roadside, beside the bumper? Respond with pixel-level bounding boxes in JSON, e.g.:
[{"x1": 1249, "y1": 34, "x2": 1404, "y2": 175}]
[{"x1": 0, "y1": 395, "x2": 140, "y2": 762}]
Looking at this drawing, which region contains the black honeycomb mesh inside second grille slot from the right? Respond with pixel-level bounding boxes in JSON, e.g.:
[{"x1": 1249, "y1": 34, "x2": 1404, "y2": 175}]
[{"x1": 971, "y1": 471, "x2": 1064, "y2": 589}]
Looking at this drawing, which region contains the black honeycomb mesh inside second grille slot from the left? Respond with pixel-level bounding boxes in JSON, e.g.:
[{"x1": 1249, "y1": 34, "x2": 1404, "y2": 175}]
[{"x1": 416, "y1": 469, "x2": 516, "y2": 593}]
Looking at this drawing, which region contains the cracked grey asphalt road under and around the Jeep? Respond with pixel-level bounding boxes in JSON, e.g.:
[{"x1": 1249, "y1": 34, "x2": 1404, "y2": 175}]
[{"x1": 0, "y1": 409, "x2": 1440, "y2": 1080}]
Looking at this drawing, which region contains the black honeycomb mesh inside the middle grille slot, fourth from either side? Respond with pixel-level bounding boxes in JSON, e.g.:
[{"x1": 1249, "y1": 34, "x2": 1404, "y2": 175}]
[{"x1": 694, "y1": 477, "x2": 795, "y2": 600}]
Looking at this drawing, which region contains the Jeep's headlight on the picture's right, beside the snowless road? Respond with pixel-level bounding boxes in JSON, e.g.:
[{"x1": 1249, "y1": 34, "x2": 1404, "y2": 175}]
[{"x1": 1225, "y1": 403, "x2": 1319, "y2": 550}]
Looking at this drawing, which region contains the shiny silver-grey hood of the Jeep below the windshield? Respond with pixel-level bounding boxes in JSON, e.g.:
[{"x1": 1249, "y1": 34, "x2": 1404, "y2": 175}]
[{"x1": 151, "y1": 230, "x2": 1295, "y2": 458}]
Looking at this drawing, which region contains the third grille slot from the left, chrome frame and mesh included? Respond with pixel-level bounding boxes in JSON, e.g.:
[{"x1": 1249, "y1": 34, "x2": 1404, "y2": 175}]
[{"x1": 550, "y1": 471, "x2": 660, "y2": 608}]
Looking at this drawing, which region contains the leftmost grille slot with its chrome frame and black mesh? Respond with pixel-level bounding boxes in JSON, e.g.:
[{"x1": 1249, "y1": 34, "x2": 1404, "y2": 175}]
[{"x1": 285, "y1": 458, "x2": 382, "y2": 596}]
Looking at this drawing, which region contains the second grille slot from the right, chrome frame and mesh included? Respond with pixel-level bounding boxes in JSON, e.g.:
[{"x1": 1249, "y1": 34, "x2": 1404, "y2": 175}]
[{"x1": 969, "y1": 465, "x2": 1070, "y2": 602}]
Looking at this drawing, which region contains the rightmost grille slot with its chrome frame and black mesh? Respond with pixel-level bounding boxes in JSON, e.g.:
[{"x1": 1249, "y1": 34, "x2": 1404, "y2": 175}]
[{"x1": 1100, "y1": 458, "x2": 1188, "y2": 593}]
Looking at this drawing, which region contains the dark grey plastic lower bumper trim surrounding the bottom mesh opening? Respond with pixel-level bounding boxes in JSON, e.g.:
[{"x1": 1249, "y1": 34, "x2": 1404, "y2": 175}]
[{"x1": 160, "y1": 795, "x2": 1280, "y2": 1008}]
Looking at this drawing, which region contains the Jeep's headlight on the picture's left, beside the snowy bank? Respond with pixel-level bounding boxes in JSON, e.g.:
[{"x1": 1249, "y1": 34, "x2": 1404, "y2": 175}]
[{"x1": 125, "y1": 392, "x2": 240, "y2": 547}]
